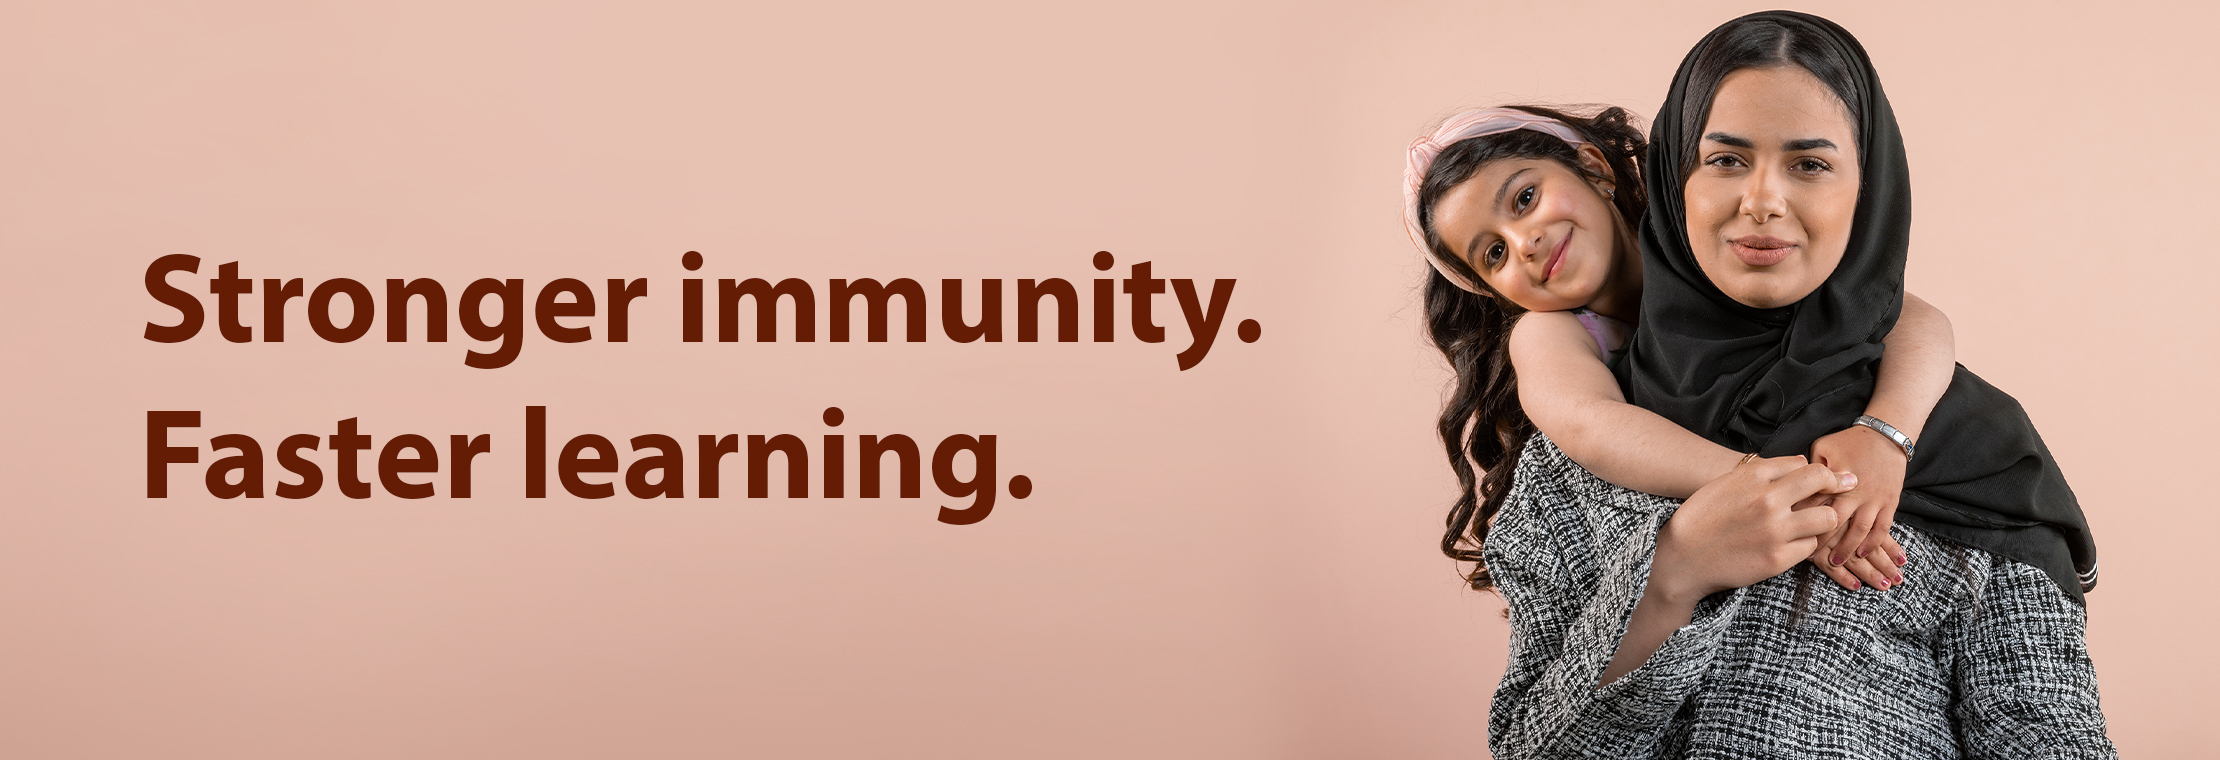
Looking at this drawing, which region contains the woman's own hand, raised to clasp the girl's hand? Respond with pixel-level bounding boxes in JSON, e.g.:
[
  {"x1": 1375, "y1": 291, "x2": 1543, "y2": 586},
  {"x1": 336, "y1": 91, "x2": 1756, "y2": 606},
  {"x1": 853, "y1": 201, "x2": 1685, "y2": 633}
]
[{"x1": 1649, "y1": 456, "x2": 1860, "y2": 607}]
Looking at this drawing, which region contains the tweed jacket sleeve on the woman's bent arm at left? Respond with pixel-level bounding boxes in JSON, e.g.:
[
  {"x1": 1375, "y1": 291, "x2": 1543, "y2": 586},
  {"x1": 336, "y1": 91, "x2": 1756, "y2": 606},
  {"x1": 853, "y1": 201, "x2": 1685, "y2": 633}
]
[{"x1": 1483, "y1": 440, "x2": 1747, "y2": 758}]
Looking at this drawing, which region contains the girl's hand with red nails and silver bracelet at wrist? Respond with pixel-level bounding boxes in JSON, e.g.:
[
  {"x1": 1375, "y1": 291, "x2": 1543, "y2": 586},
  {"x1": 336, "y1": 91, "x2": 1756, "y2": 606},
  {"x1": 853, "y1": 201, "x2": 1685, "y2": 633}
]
[{"x1": 1812, "y1": 424, "x2": 1907, "y2": 589}]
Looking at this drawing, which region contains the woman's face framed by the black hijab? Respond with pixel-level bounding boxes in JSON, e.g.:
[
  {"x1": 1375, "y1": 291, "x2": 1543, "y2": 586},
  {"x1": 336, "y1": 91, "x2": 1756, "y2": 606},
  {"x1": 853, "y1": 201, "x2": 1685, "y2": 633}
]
[{"x1": 1683, "y1": 67, "x2": 1858, "y2": 309}]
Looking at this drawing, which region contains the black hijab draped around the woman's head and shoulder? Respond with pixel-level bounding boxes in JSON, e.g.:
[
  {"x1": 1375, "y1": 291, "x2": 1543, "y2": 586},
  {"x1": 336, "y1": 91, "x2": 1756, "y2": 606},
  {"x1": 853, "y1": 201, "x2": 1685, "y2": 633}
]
[{"x1": 1618, "y1": 11, "x2": 2096, "y2": 602}]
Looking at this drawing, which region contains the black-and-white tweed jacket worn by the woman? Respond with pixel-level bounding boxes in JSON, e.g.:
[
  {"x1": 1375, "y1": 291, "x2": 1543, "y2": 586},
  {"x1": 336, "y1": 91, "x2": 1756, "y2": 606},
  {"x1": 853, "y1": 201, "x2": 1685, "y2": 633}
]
[{"x1": 1483, "y1": 433, "x2": 2118, "y2": 760}]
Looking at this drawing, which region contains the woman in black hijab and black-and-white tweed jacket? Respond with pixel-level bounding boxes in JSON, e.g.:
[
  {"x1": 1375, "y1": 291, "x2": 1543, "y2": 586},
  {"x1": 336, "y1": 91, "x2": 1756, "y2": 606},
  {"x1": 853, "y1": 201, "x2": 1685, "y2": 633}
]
[{"x1": 1485, "y1": 11, "x2": 2116, "y2": 758}]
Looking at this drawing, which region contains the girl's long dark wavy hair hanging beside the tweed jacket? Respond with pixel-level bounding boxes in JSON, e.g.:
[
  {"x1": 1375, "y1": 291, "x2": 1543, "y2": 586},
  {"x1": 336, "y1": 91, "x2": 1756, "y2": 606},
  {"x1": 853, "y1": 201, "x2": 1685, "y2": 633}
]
[{"x1": 1419, "y1": 107, "x2": 1647, "y2": 591}]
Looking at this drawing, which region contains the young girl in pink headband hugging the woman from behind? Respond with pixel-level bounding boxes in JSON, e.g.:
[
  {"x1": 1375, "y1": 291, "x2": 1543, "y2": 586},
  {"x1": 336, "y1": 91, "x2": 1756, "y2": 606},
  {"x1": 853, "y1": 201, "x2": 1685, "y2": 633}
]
[{"x1": 1405, "y1": 107, "x2": 1956, "y2": 591}]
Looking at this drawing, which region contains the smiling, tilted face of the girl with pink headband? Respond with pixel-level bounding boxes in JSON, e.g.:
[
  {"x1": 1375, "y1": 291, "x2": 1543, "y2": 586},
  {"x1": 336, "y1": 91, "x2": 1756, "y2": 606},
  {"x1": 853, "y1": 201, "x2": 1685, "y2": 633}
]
[{"x1": 1434, "y1": 144, "x2": 1627, "y2": 311}]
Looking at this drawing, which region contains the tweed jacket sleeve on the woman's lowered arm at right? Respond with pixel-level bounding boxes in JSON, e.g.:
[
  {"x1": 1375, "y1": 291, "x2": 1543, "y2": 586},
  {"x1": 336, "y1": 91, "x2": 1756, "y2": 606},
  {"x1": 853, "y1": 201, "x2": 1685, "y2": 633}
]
[{"x1": 1943, "y1": 558, "x2": 2120, "y2": 760}]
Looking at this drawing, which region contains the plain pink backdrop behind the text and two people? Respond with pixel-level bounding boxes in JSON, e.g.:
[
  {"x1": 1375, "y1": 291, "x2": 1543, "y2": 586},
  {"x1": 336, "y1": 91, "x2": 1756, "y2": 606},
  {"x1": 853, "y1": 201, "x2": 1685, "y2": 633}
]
[{"x1": 0, "y1": 2, "x2": 2220, "y2": 758}]
